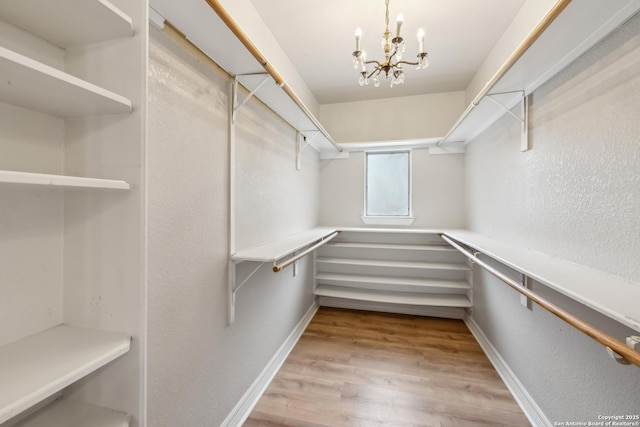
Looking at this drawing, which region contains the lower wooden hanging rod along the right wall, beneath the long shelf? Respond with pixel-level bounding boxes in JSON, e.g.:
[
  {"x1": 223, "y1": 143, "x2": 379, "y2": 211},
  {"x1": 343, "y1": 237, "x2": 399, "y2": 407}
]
[{"x1": 440, "y1": 234, "x2": 640, "y2": 367}]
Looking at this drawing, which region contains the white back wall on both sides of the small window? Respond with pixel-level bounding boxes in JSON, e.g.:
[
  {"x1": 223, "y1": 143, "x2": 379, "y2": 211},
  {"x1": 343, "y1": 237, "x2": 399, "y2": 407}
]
[{"x1": 320, "y1": 149, "x2": 465, "y2": 228}]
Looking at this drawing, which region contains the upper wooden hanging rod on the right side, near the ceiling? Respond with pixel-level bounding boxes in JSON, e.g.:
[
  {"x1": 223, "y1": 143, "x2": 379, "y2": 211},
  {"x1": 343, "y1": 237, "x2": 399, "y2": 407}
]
[{"x1": 440, "y1": 0, "x2": 571, "y2": 147}]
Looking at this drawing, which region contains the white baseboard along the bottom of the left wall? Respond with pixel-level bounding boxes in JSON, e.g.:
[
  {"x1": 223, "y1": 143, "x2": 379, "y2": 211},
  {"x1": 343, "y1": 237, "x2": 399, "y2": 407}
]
[{"x1": 220, "y1": 302, "x2": 319, "y2": 427}]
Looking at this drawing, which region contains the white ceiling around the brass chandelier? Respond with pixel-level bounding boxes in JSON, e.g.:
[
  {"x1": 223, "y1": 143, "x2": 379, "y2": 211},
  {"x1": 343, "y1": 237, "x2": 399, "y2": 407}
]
[{"x1": 251, "y1": 0, "x2": 525, "y2": 104}]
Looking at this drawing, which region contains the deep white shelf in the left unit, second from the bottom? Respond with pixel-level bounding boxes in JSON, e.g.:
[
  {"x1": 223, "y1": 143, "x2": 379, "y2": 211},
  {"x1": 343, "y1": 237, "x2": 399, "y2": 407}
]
[{"x1": 0, "y1": 325, "x2": 130, "y2": 423}]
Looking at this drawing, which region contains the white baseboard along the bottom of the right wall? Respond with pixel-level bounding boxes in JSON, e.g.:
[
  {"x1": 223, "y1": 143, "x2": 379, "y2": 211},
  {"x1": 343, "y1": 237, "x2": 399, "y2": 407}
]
[{"x1": 464, "y1": 316, "x2": 553, "y2": 427}]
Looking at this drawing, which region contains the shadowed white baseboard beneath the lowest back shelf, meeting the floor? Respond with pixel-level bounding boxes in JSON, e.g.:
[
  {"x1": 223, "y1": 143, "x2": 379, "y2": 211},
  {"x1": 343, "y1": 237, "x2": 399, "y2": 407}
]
[{"x1": 318, "y1": 297, "x2": 465, "y2": 319}]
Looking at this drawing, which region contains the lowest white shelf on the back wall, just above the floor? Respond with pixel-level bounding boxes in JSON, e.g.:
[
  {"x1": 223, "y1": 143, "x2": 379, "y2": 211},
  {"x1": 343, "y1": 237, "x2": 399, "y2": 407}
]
[{"x1": 314, "y1": 285, "x2": 471, "y2": 308}]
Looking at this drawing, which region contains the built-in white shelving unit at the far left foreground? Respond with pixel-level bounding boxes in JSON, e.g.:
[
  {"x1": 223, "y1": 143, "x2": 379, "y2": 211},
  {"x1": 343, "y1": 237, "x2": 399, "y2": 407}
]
[{"x1": 0, "y1": 0, "x2": 148, "y2": 427}]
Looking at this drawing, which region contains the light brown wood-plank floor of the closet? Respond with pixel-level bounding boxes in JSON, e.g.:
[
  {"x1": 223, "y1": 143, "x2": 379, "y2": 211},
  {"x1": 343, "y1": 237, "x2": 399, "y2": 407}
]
[{"x1": 244, "y1": 307, "x2": 530, "y2": 427}]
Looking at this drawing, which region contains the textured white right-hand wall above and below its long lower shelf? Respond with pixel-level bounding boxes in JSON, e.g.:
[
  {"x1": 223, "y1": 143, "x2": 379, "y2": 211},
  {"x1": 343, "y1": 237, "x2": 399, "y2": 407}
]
[{"x1": 466, "y1": 11, "x2": 640, "y2": 423}]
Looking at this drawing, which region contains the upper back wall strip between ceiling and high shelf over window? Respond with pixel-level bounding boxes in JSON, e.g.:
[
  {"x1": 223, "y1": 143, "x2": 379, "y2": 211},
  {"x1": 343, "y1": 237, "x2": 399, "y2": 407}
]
[{"x1": 318, "y1": 92, "x2": 465, "y2": 142}]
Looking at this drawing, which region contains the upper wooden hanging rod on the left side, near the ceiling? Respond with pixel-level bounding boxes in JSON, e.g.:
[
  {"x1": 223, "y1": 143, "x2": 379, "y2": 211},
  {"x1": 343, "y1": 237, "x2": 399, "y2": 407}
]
[{"x1": 207, "y1": 0, "x2": 342, "y2": 151}]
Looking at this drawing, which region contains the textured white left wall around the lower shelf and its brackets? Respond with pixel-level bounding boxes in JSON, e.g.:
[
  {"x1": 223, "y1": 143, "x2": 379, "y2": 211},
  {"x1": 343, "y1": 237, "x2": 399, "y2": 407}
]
[{"x1": 148, "y1": 30, "x2": 319, "y2": 427}]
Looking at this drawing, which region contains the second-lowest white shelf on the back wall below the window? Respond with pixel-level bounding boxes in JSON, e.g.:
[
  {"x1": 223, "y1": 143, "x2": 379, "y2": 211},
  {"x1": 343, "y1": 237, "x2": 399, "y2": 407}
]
[{"x1": 316, "y1": 273, "x2": 471, "y2": 293}]
